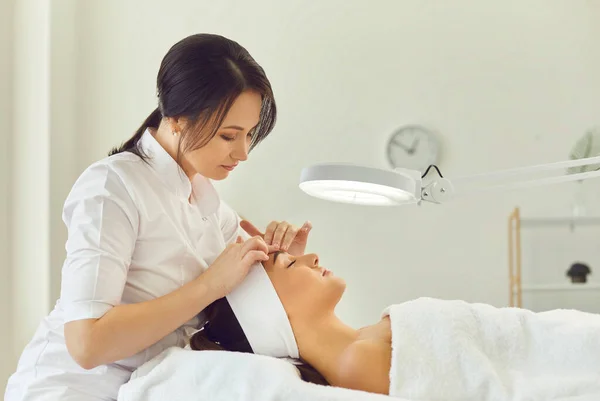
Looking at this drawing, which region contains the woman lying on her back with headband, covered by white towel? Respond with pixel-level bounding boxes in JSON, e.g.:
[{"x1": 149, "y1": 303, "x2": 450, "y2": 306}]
[{"x1": 190, "y1": 252, "x2": 600, "y2": 401}]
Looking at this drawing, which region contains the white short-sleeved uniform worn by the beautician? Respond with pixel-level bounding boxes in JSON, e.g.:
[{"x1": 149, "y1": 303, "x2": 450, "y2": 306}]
[{"x1": 5, "y1": 131, "x2": 247, "y2": 401}]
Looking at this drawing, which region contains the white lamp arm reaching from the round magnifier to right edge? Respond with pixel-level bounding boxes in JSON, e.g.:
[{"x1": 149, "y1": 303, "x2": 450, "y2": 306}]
[{"x1": 421, "y1": 156, "x2": 600, "y2": 203}]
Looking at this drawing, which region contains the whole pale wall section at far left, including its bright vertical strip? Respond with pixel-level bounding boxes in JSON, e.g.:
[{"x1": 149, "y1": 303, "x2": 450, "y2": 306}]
[{"x1": 0, "y1": 0, "x2": 77, "y2": 388}]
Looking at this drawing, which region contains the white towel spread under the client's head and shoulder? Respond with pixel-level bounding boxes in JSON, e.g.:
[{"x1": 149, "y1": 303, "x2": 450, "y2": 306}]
[{"x1": 118, "y1": 348, "x2": 398, "y2": 401}]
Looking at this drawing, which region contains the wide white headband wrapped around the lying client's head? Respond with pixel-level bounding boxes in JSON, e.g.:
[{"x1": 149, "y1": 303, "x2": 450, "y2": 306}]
[{"x1": 226, "y1": 263, "x2": 299, "y2": 359}]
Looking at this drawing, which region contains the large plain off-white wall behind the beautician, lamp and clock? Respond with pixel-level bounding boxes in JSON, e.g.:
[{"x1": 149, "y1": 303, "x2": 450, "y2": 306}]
[{"x1": 72, "y1": 0, "x2": 600, "y2": 324}]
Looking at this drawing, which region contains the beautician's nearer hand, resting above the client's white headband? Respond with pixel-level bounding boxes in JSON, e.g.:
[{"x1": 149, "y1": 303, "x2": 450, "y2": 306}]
[{"x1": 199, "y1": 236, "x2": 269, "y2": 300}]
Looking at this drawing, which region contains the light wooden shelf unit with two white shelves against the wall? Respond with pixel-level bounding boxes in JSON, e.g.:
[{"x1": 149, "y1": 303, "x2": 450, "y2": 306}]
[{"x1": 508, "y1": 207, "x2": 600, "y2": 308}]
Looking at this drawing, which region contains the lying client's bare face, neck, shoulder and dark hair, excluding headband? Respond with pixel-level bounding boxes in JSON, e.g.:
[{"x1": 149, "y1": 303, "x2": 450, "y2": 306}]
[{"x1": 190, "y1": 252, "x2": 391, "y2": 394}]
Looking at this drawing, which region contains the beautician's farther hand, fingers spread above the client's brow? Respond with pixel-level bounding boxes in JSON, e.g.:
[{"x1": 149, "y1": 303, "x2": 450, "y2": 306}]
[{"x1": 240, "y1": 220, "x2": 312, "y2": 256}]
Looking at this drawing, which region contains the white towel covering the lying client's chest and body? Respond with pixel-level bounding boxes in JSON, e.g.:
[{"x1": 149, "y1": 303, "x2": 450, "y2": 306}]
[{"x1": 383, "y1": 298, "x2": 600, "y2": 401}]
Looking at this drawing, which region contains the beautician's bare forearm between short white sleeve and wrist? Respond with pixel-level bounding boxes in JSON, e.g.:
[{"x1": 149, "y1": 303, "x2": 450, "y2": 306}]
[{"x1": 69, "y1": 275, "x2": 216, "y2": 369}]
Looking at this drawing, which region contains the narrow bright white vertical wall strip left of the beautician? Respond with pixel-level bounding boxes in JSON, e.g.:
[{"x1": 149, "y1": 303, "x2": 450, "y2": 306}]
[{"x1": 11, "y1": 0, "x2": 50, "y2": 354}]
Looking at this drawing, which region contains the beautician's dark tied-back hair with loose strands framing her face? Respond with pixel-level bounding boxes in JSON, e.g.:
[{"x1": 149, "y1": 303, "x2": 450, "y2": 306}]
[{"x1": 109, "y1": 34, "x2": 277, "y2": 160}]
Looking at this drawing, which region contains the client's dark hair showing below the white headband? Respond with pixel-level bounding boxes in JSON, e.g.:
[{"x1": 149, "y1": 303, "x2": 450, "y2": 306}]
[{"x1": 190, "y1": 298, "x2": 329, "y2": 386}]
